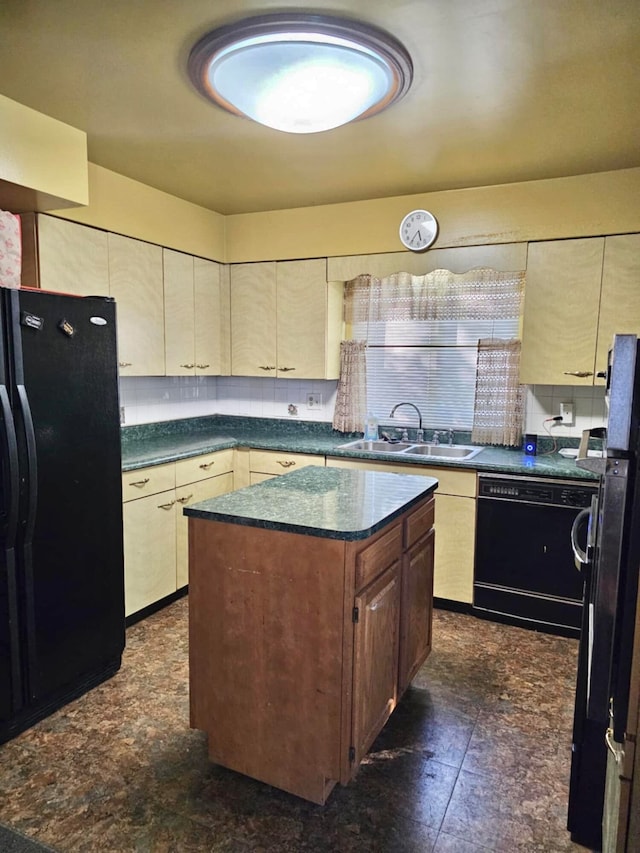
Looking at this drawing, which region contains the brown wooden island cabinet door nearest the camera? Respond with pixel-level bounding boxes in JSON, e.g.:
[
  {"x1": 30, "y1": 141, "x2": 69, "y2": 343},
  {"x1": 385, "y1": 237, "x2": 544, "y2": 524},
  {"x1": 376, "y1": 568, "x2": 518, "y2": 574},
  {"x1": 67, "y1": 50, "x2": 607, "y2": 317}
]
[{"x1": 352, "y1": 561, "x2": 400, "y2": 772}]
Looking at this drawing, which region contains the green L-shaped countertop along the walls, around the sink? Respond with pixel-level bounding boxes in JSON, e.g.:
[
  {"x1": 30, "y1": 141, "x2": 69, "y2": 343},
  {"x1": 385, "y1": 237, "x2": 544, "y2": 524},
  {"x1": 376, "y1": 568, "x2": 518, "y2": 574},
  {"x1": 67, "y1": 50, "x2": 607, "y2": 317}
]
[{"x1": 122, "y1": 415, "x2": 597, "y2": 480}]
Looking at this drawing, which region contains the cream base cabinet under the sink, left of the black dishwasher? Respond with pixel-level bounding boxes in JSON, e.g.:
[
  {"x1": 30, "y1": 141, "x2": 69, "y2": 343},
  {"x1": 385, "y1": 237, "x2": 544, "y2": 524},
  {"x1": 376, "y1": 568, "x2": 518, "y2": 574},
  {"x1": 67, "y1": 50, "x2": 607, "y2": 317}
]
[{"x1": 327, "y1": 456, "x2": 476, "y2": 604}]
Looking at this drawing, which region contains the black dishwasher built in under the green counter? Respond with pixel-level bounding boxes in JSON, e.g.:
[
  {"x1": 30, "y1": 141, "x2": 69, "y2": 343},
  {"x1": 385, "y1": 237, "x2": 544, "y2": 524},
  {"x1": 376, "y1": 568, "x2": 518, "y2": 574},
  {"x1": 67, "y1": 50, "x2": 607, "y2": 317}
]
[{"x1": 473, "y1": 474, "x2": 598, "y2": 637}]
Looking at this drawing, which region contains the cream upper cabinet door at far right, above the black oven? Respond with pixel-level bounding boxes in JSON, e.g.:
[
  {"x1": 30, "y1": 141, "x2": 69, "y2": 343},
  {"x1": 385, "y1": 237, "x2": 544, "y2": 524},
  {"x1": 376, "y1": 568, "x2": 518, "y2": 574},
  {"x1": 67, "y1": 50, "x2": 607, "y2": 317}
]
[{"x1": 595, "y1": 234, "x2": 640, "y2": 385}]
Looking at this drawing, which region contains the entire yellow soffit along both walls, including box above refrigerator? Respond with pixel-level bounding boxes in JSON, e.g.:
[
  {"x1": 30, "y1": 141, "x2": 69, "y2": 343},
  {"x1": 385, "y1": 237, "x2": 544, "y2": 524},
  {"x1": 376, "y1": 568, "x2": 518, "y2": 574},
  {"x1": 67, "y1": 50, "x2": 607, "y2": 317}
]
[{"x1": 0, "y1": 96, "x2": 640, "y2": 263}]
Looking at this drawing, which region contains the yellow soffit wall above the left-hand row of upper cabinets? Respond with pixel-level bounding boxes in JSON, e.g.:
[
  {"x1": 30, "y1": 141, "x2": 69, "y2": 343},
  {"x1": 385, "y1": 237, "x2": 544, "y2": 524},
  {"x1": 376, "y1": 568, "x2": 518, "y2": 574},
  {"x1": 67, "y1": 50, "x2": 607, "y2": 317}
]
[{"x1": 50, "y1": 163, "x2": 225, "y2": 262}]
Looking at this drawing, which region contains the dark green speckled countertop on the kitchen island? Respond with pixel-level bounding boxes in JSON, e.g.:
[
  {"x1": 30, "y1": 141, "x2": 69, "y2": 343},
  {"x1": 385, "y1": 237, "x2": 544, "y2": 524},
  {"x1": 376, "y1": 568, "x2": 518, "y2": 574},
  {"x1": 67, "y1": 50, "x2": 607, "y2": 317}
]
[{"x1": 183, "y1": 465, "x2": 438, "y2": 541}]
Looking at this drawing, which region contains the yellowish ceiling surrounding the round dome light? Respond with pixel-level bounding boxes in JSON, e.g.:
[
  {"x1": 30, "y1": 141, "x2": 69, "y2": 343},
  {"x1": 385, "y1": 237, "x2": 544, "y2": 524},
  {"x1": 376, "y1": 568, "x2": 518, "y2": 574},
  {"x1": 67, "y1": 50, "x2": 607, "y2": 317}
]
[{"x1": 0, "y1": 0, "x2": 640, "y2": 214}]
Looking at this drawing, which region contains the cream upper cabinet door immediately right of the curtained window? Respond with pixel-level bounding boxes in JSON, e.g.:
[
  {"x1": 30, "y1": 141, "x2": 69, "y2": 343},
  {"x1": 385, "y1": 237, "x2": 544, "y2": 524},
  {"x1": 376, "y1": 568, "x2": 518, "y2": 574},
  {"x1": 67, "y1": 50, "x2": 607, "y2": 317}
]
[{"x1": 520, "y1": 237, "x2": 604, "y2": 385}]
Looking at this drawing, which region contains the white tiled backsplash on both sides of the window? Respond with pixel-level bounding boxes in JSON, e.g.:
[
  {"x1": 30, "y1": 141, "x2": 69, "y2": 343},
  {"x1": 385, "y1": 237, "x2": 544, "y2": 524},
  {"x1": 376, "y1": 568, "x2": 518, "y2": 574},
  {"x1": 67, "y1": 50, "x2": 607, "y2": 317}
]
[{"x1": 120, "y1": 376, "x2": 605, "y2": 438}]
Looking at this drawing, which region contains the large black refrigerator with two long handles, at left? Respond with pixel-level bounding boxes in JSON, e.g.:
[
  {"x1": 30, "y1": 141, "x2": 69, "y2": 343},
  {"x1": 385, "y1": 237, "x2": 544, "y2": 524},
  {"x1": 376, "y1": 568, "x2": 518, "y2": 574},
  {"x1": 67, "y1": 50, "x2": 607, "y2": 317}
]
[{"x1": 0, "y1": 288, "x2": 125, "y2": 743}]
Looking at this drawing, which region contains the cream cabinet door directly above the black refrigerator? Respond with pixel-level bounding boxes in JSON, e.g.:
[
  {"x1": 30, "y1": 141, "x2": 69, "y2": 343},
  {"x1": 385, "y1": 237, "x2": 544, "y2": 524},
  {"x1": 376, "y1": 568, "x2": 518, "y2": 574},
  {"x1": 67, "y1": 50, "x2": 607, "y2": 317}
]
[{"x1": 37, "y1": 215, "x2": 109, "y2": 296}]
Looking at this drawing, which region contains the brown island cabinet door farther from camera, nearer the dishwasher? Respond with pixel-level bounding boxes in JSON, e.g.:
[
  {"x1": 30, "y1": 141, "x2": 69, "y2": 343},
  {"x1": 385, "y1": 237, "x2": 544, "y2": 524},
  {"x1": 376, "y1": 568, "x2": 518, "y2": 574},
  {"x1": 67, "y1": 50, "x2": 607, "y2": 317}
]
[{"x1": 398, "y1": 530, "x2": 435, "y2": 697}]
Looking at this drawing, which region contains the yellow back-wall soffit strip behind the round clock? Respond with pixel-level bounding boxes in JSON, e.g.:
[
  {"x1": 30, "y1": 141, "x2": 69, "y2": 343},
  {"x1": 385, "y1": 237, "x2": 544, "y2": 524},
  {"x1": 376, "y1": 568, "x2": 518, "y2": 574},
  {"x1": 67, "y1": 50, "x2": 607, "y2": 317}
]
[{"x1": 226, "y1": 169, "x2": 640, "y2": 263}]
